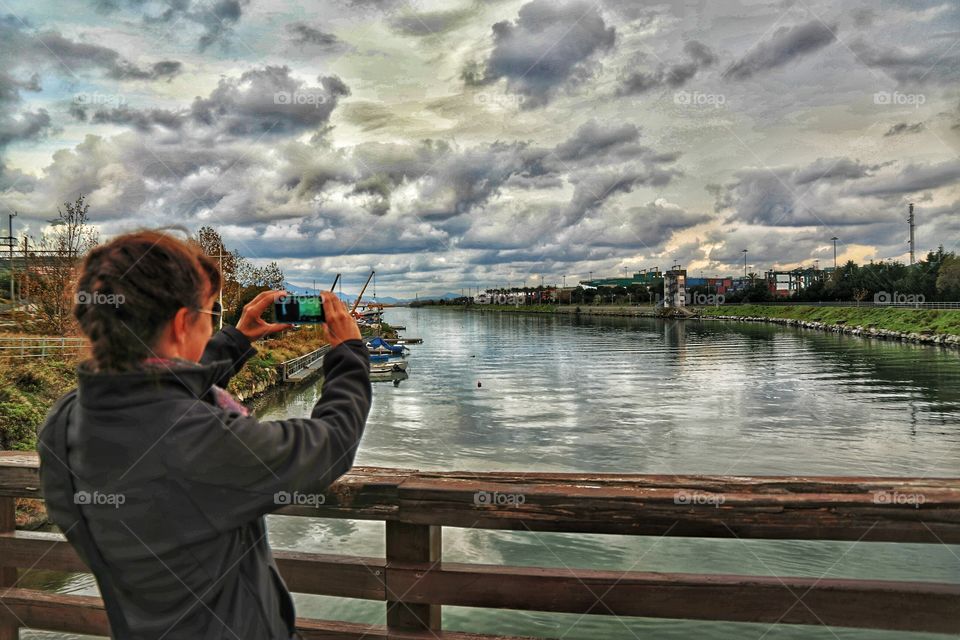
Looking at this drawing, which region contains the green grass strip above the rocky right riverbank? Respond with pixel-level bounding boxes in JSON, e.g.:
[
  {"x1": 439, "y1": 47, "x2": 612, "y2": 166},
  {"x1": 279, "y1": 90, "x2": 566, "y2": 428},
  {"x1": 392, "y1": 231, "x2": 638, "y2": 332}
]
[{"x1": 698, "y1": 304, "x2": 960, "y2": 335}]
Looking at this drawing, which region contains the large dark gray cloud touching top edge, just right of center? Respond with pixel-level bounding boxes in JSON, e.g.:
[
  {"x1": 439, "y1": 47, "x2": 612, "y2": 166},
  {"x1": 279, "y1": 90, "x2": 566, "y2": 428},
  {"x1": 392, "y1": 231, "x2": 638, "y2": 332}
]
[{"x1": 463, "y1": 0, "x2": 616, "y2": 108}]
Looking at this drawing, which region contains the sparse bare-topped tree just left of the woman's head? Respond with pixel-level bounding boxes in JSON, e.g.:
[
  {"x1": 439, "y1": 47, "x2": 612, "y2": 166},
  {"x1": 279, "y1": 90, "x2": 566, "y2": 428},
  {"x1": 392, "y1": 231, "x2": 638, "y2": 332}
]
[{"x1": 27, "y1": 194, "x2": 99, "y2": 335}]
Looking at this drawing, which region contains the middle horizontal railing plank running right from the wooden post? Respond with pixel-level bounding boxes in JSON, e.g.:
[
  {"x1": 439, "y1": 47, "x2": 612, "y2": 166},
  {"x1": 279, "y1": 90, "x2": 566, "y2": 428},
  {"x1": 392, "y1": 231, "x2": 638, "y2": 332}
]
[{"x1": 387, "y1": 562, "x2": 960, "y2": 633}]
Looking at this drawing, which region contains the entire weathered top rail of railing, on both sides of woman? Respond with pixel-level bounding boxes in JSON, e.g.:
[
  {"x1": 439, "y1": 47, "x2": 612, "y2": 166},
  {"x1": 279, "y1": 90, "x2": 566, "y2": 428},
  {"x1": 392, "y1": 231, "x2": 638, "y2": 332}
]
[{"x1": 0, "y1": 453, "x2": 960, "y2": 544}]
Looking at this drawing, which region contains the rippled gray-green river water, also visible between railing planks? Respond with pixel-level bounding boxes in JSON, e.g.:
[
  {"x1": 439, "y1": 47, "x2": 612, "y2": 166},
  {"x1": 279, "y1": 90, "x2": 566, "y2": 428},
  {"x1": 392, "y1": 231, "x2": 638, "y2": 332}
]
[{"x1": 24, "y1": 308, "x2": 960, "y2": 640}]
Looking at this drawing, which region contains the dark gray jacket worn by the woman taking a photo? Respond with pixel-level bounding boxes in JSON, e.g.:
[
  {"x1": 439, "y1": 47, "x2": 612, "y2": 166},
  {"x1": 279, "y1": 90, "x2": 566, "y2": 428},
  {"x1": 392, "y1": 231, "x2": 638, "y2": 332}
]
[{"x1": 38, "y1": 327, "x2": 371, "y2": 640}]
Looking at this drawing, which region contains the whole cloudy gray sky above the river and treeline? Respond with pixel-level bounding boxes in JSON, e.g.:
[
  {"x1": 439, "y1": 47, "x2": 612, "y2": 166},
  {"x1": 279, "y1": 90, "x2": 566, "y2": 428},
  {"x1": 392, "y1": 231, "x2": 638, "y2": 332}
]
[{"x1": 0, "y1": 0, "x2": 960, "y2": 295}]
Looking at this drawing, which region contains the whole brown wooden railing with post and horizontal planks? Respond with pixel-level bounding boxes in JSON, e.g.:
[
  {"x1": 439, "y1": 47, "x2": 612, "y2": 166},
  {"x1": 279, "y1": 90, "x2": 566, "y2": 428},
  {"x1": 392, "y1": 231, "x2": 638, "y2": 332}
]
[{"x1": 0, "y1": 453, "x2": 960, "y2": 640}]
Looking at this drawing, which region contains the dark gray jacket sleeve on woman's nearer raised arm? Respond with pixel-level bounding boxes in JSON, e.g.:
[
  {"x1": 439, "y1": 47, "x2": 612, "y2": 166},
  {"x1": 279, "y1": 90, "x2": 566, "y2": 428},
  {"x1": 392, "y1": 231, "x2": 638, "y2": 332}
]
[{"x1": 168, "y1": 340, "x2": 372, "y2": 531}]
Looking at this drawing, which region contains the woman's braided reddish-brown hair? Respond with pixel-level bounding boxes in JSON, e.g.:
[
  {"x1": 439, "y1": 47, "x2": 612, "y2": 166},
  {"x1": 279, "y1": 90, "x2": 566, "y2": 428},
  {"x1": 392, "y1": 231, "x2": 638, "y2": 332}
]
[{"x1": 73, "y1": 231, "x2": 221, "y2": 371}]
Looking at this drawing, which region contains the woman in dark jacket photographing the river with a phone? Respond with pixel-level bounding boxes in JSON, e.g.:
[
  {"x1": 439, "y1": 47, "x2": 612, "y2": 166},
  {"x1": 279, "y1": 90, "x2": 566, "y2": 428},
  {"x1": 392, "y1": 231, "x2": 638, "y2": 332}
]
[{"x1": 38, "y1": 231, "x2": 371, "y2": 640}]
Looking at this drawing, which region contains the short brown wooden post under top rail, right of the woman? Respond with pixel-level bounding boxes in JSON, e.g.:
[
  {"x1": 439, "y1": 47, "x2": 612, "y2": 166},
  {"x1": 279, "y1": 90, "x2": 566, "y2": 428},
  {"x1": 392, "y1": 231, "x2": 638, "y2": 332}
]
[{"x1": 386, "y1": 520, "x2": 441, "y2": 631}]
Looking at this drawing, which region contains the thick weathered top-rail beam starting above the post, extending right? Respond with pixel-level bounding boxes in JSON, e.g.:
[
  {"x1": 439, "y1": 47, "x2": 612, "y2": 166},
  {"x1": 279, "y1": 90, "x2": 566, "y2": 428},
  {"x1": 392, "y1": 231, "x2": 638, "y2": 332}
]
[{"x1": 398, "y1": 476, "x2": 960, "y2": 544}]
